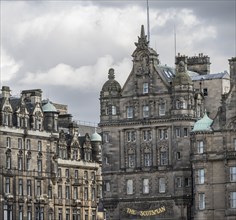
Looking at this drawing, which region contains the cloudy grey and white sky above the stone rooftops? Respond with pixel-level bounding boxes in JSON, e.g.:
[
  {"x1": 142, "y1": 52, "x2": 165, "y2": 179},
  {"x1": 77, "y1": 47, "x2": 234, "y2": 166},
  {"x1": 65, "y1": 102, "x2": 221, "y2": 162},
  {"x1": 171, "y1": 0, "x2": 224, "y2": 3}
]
[{"x1": 0, "y1": 0, "x2": 236, "y2": 123}]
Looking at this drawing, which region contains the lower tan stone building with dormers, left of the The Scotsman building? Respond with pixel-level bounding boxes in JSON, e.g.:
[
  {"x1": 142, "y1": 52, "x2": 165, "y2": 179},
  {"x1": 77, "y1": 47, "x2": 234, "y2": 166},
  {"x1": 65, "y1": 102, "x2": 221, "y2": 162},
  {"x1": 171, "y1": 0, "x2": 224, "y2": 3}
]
[{"x1": 0, "y1": 86, "x2": 102, "y2": 220}]
